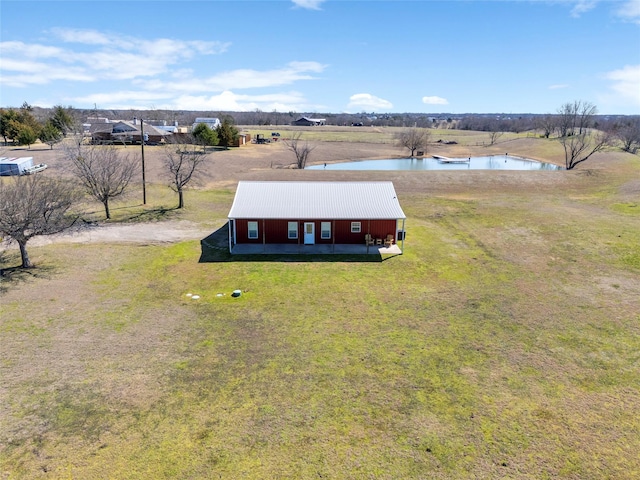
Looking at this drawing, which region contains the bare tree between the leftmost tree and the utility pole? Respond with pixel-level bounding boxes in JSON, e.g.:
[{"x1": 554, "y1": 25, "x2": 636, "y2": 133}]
[{"x1": 66, "y1": 144, "x2": 138, "y2": 219}]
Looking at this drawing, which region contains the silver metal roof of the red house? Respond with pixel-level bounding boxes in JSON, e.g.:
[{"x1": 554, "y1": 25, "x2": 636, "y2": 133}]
[{"x1": 229, "y1": 181, "x2": 406, "y2": 220}]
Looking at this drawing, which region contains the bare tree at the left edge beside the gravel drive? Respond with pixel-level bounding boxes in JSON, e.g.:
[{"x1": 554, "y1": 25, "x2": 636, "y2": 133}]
[{"x1": 0, "y1": 175, "x2": 77, "y2": 268}]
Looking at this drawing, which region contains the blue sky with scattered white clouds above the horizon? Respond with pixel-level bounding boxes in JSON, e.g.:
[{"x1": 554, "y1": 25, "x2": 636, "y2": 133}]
[{"x1": 0, "y1": 0, "x2": 640, "y2": 114}]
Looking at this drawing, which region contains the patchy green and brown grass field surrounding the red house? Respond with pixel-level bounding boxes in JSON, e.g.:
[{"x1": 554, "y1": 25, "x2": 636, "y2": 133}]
[{"x1": 0, "y1": 127, "x2": 640, "y2": 480}]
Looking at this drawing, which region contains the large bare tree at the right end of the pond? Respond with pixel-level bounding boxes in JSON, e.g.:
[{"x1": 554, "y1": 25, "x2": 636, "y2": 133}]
[{"x1": 558, "y1": 100, "x2": 612, "y2": 170}]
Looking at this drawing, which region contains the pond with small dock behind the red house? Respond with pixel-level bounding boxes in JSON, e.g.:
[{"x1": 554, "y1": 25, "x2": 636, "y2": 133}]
[{"x1": 306, "y1": 155, "x2": 562, "y2": 170}]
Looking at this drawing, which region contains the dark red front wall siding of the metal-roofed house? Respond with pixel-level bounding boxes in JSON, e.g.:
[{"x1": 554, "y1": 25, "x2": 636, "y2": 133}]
[{"x1": 234, "y1": 219, "x2": 397, "y2": 244}]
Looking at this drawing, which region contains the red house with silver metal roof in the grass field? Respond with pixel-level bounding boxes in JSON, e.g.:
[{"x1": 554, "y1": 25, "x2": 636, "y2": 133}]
[{"x1": 228, "y1": 181, "x2": 406, "y2": 253}]
